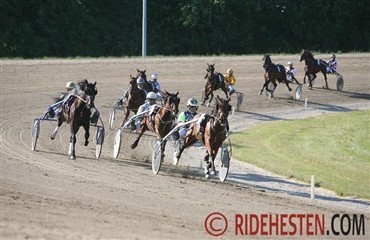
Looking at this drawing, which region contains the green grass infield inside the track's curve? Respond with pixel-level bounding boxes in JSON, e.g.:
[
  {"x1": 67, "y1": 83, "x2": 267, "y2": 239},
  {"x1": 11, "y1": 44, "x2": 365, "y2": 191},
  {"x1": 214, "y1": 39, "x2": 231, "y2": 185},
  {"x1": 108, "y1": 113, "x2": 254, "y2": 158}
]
[{"x1": 230, "y1": 111, "x2": 370, "y2": 199}]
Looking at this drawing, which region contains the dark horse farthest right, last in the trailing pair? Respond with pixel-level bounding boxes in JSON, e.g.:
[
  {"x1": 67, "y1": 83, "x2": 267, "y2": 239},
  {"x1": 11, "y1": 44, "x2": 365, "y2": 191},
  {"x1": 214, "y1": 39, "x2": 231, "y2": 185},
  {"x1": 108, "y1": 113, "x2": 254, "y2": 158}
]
[{"x1": 299, "y1": 49, "x2": 329, "y2": 89}]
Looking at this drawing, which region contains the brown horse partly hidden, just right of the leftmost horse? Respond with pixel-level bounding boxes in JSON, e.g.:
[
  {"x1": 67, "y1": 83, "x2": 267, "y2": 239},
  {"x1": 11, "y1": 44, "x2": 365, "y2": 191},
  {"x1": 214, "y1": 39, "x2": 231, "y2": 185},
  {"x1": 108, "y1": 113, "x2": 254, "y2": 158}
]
[{"x1": 121, "y1": 75, "x2": 146, "y2": 126}]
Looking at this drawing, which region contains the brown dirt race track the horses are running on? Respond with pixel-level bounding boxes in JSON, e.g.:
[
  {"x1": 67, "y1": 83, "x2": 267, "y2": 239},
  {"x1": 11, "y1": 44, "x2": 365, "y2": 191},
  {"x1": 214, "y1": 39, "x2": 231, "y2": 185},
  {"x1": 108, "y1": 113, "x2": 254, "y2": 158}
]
[{"x1": 0, "y1": 54, "x2": 370, "y2": 239}]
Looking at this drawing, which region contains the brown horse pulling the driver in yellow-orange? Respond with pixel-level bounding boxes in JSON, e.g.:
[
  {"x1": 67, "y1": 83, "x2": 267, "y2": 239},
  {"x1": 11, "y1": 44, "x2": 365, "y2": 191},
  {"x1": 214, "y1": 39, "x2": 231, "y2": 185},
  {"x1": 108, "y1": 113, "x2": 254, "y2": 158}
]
[{"x1": 202, "y1": 63, "x2": 229, "y2": 107}]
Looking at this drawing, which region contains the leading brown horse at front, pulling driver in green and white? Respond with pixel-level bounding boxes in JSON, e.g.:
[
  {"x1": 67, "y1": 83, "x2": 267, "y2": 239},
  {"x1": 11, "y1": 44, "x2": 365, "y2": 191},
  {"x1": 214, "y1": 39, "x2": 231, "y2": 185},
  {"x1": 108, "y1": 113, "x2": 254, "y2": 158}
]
[{"x1": 176, "y1": 95, "x2": 232, "y2": 178}]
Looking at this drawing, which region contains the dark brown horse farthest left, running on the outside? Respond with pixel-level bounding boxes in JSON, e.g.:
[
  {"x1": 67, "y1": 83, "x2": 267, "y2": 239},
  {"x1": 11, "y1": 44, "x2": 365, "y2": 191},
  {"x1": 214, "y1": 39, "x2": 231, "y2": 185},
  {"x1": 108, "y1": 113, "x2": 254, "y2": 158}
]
[{"x1": 50, "y1": 79, "x2": 98, "y2": 159}]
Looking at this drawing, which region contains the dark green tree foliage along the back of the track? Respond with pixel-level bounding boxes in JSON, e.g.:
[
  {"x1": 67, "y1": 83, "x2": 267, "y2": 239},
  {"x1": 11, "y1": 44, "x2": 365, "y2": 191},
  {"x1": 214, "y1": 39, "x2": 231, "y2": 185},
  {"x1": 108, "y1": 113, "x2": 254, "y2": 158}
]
[{"x1": 0, "y1": 0, "x2": 370, "y2": 58}]
